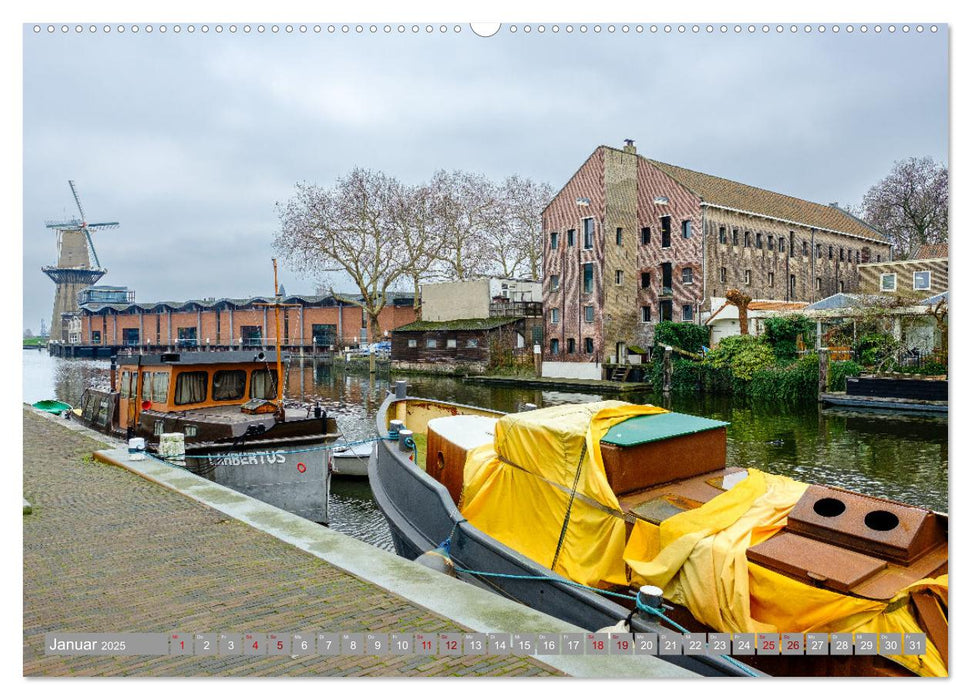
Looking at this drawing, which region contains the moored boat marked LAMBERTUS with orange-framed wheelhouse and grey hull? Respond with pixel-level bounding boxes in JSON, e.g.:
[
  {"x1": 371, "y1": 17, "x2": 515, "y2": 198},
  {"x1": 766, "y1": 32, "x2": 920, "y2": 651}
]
[{"x1": 75, "y1": 350, "x2": 339, "y2": 523}]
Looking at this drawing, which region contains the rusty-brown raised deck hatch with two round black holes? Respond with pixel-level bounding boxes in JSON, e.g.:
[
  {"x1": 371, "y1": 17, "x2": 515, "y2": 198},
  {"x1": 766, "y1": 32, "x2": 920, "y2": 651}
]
[{"x1": 787, "y1": 486, "x2": 947, "y2": 566}]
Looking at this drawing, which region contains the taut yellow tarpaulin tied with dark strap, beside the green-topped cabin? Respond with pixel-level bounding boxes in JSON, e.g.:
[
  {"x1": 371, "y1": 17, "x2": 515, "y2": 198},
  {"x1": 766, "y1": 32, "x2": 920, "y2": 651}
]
[{"x1": 460, "y1": 401, "x2": 666, "y2": 586}]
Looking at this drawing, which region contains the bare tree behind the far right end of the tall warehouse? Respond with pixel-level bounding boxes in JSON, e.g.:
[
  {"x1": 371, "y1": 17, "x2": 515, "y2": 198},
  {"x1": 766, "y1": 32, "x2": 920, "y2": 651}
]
[{"x1": 863, "y1": 156, "x2": 948, "y2": 258}]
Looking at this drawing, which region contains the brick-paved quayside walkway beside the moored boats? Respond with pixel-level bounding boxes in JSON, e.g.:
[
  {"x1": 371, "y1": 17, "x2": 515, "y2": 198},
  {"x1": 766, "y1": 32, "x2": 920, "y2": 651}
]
[{"x1": 23, "y1": 409, "x2": 558, "y2": 676}]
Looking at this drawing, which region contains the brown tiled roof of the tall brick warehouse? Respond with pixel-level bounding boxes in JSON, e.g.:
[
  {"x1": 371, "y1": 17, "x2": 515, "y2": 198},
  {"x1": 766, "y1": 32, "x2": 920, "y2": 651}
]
[{"x1": 645, "y1": 158, "x2": 887, "y2": 243}]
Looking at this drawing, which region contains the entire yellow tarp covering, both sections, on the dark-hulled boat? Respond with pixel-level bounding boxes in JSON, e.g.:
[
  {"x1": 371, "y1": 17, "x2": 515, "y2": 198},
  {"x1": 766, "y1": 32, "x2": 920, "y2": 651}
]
[{"x1": 460, "y1": 401, "x2": 948, "y2": 676}]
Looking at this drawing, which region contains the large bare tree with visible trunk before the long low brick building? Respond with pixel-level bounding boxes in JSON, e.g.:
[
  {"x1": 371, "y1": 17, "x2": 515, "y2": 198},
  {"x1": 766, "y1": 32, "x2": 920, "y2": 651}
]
[{"x1": 273, "y1": 168, "x2": 404, "y2": 339}]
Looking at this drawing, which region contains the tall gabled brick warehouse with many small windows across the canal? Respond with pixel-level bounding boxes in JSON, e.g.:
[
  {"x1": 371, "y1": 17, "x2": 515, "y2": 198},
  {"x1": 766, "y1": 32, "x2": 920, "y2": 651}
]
[{"x1": 543, "y1": 141, "x2": 890, "y2": 376}]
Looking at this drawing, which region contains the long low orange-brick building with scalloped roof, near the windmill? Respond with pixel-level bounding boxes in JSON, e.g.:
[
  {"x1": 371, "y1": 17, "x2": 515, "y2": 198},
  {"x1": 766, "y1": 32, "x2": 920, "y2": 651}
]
[{"x1": 80, "y1": 295, "x2": 415, "y2": 349}]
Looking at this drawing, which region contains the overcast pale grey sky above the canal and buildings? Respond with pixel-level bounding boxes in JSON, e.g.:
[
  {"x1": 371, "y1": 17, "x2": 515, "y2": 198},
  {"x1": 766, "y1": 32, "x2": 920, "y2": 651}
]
[{"x1": 23, "y1": 24, "x2": 948, "y2": 331}]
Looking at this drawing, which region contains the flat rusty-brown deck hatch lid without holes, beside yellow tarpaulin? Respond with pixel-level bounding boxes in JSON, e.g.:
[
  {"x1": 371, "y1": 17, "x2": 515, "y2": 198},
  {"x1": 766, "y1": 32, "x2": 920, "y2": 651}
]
[{"x1": 748, "y1": 532, "x2": 887, "y2": 593}]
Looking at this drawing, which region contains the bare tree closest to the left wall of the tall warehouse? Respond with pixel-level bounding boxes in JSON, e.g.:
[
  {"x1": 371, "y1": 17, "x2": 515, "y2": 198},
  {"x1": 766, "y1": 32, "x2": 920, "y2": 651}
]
[{"x1": 502, "y1": 175, "x2": 553, "y2": 280}]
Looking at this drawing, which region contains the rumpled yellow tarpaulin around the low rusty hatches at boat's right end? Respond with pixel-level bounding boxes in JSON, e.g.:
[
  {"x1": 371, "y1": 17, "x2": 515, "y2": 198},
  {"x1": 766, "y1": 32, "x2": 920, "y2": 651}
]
[{"x1": 624, "y1": 469, "x2": 947, "y2": 676}]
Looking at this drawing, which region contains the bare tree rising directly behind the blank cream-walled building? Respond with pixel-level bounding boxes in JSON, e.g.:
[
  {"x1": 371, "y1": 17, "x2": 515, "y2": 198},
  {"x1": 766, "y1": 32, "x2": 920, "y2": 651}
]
[{"x1": 430, "y1": 170, "x2": 499, "y2": 279}]
